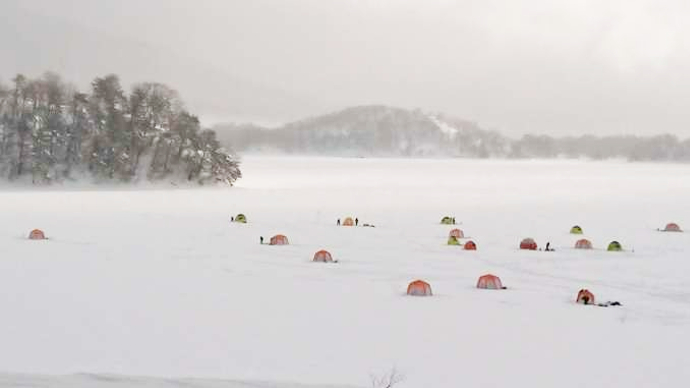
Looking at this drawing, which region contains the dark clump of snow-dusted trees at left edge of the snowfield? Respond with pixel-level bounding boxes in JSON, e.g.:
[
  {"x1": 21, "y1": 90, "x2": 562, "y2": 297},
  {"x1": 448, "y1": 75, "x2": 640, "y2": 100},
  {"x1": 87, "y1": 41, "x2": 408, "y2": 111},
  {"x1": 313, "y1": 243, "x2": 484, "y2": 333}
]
[{"x1": 0, "y1": 73, "x2": 241, "y2": 184}]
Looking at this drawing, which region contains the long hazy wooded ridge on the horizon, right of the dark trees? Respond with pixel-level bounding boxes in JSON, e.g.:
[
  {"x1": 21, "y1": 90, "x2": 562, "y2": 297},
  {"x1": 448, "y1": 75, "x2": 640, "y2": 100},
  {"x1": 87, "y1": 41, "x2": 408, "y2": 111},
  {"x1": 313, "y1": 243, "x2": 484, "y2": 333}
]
[{"x1": 213, "y1": 105, "x2": 690, "y2": 161}]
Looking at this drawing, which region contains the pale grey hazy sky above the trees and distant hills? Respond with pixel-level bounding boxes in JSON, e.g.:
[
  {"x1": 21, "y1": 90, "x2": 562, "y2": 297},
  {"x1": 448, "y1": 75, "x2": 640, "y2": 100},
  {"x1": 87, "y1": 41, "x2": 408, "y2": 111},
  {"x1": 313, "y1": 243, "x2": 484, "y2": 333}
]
[{"x1": 0, "y1": 0, "x2": 690, "y2": 137}]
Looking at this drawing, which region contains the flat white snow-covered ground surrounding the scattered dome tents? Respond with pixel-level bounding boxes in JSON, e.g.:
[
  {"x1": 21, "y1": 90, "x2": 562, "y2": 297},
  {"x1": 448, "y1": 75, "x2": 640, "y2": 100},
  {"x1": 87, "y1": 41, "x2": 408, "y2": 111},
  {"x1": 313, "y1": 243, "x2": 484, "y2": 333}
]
[{"x1": 0, "y1": 157, "x2": 690, "y2": 388}]
